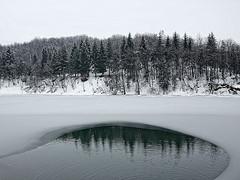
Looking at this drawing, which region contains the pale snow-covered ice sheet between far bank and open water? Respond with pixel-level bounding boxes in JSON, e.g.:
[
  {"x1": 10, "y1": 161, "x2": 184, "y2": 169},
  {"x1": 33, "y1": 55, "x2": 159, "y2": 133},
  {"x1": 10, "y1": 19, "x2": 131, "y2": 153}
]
[{"x1": 0, "y1": 95, "x2": 240, "y2": 180}]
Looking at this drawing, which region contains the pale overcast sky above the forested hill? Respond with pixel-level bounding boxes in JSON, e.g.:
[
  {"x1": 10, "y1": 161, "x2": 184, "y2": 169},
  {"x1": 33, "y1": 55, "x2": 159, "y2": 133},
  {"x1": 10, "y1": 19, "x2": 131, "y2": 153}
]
[{"x1": 0, "y1": 0, "x2": 240, "y2": 44}]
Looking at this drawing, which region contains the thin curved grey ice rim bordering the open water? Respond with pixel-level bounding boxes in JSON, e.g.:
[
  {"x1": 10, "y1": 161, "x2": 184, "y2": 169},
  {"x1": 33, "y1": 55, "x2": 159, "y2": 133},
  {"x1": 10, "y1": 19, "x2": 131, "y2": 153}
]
[{"x1": 0, "y1": 121, "x2": 231, "y2": 179}]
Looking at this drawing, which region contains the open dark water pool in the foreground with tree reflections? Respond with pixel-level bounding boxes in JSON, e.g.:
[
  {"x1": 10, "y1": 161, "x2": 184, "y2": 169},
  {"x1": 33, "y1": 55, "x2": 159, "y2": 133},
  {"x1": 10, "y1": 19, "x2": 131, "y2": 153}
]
[{"x1": 0, "y1": 126, "x2": 229, "y2": 180}]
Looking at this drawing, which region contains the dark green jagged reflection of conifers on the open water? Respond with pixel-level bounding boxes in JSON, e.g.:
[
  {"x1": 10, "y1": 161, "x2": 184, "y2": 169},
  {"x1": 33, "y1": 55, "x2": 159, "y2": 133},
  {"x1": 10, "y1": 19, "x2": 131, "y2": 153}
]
[{"x1": 57, "y1": 126, "x2": 220, "y2": 159}]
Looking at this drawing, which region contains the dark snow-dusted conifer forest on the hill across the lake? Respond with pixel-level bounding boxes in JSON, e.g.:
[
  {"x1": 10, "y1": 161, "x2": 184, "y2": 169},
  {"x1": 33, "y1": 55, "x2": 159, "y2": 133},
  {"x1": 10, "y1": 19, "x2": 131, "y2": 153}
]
[{"x1": 0, "y1": 33, "x2": 240, "y2": 94}]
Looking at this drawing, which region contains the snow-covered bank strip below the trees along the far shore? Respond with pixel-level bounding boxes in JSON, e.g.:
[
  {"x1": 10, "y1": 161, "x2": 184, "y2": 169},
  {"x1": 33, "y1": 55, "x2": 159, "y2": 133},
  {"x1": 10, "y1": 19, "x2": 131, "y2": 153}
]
[{"x1": 0, "y1": 75, "x2": 240, "y2": 96}]
